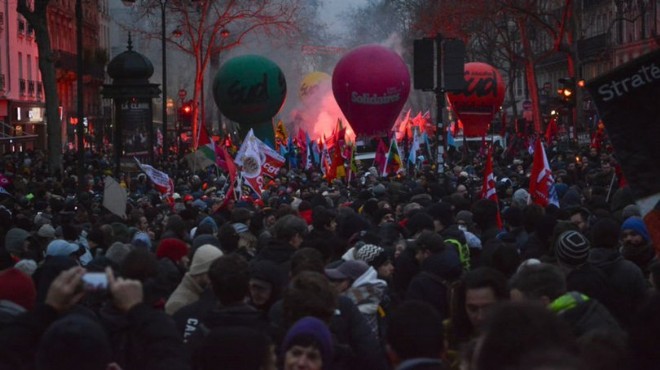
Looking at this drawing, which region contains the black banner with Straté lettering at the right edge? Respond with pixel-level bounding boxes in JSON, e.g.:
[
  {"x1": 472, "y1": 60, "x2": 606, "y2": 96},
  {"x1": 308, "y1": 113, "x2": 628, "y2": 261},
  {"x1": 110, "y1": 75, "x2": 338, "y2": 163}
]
[{"x1": 587, "y1": 50, "x2": 660, "y2": 250}]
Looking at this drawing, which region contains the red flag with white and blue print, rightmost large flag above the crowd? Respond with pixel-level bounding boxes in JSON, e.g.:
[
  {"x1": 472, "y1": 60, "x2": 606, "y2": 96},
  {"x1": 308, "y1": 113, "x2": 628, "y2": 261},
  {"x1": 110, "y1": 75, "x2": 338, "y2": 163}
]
[{"x1": 529, "y1": 138, "x2": 559, "y2": 207}]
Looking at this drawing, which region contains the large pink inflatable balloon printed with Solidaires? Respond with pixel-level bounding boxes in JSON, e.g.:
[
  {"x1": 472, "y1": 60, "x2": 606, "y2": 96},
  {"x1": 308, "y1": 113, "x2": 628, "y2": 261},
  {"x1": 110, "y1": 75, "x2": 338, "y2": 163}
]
[{"x1": 332, "y1": 44, "x2": 410, "y2": 136}]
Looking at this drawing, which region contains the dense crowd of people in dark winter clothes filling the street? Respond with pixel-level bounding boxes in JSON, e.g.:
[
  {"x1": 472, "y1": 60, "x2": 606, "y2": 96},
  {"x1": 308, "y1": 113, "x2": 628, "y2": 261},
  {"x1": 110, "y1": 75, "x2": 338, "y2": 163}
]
[{"x1": 0, "y1": 139, "x2": 660, "y2": 370}]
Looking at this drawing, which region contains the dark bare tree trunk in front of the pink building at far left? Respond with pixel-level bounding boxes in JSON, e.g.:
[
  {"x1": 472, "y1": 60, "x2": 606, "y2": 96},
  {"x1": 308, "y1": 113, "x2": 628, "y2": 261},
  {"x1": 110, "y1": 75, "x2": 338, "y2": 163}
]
[{"x1": 16, "y1": 0, "x2": 62, "y2": 175}]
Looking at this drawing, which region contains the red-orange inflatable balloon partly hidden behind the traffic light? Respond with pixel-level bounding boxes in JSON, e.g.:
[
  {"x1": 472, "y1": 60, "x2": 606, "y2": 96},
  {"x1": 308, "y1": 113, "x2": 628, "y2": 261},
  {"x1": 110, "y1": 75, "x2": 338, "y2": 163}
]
[{"x1": 447, "y1": 63, "x2": 504, "y2": 137}]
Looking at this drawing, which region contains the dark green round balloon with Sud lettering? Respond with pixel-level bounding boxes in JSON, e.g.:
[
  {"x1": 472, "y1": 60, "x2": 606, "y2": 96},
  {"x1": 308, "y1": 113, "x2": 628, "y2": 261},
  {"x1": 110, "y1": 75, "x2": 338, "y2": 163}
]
[{"x1": 213, "y1": 55, "x2": 286, "y2": 125}]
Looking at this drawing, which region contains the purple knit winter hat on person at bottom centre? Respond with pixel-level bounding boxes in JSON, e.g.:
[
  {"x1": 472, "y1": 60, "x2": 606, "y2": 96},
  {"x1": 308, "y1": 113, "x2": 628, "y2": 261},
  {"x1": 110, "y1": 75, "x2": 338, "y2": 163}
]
[{"x1": 282, "y1": 316, "x2": 333, "y2": 369}]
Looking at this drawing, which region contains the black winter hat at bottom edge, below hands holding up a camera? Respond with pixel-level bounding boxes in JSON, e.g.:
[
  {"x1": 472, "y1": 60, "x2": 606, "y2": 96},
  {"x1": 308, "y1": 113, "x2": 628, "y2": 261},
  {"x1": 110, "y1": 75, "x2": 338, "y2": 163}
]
[{"x1": 36, "y1": 314, "x2": 112, "y2": 370}]
